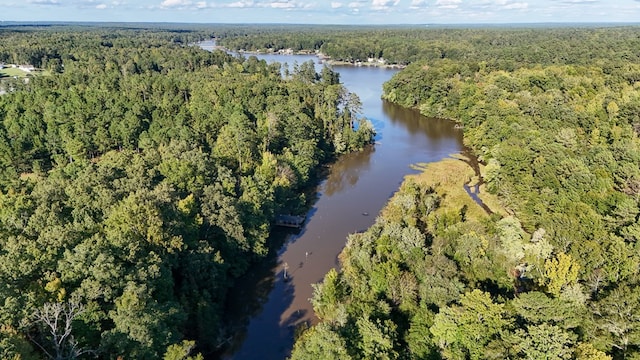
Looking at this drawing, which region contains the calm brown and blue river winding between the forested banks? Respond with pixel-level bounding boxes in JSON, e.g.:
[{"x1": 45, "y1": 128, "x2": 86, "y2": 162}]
[{"x1": 203, "y1": 44, "x2": 462, "y2": 360}]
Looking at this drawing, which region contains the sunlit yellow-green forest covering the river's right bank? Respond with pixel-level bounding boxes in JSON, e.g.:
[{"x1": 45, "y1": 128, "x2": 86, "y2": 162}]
[{"x1": 292, "y1": 28, "x2": 640, "y2": 359}]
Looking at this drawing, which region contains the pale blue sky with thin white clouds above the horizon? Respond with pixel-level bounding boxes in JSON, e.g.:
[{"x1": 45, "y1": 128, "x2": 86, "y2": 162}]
[{"x1": 0, "y1": 0, "x2": 640, "y2": 24}]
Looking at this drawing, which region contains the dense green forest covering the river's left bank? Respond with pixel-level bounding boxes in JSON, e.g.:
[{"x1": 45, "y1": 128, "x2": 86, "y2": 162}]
[{"x1": 0, "y1": 28, "x2": 373, "y2": 359}]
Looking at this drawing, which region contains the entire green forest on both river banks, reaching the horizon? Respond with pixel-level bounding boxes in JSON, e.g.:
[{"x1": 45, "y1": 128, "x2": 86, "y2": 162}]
[{"x1": 0, "y1": 25, "x2": 640, "y2": 360}]
